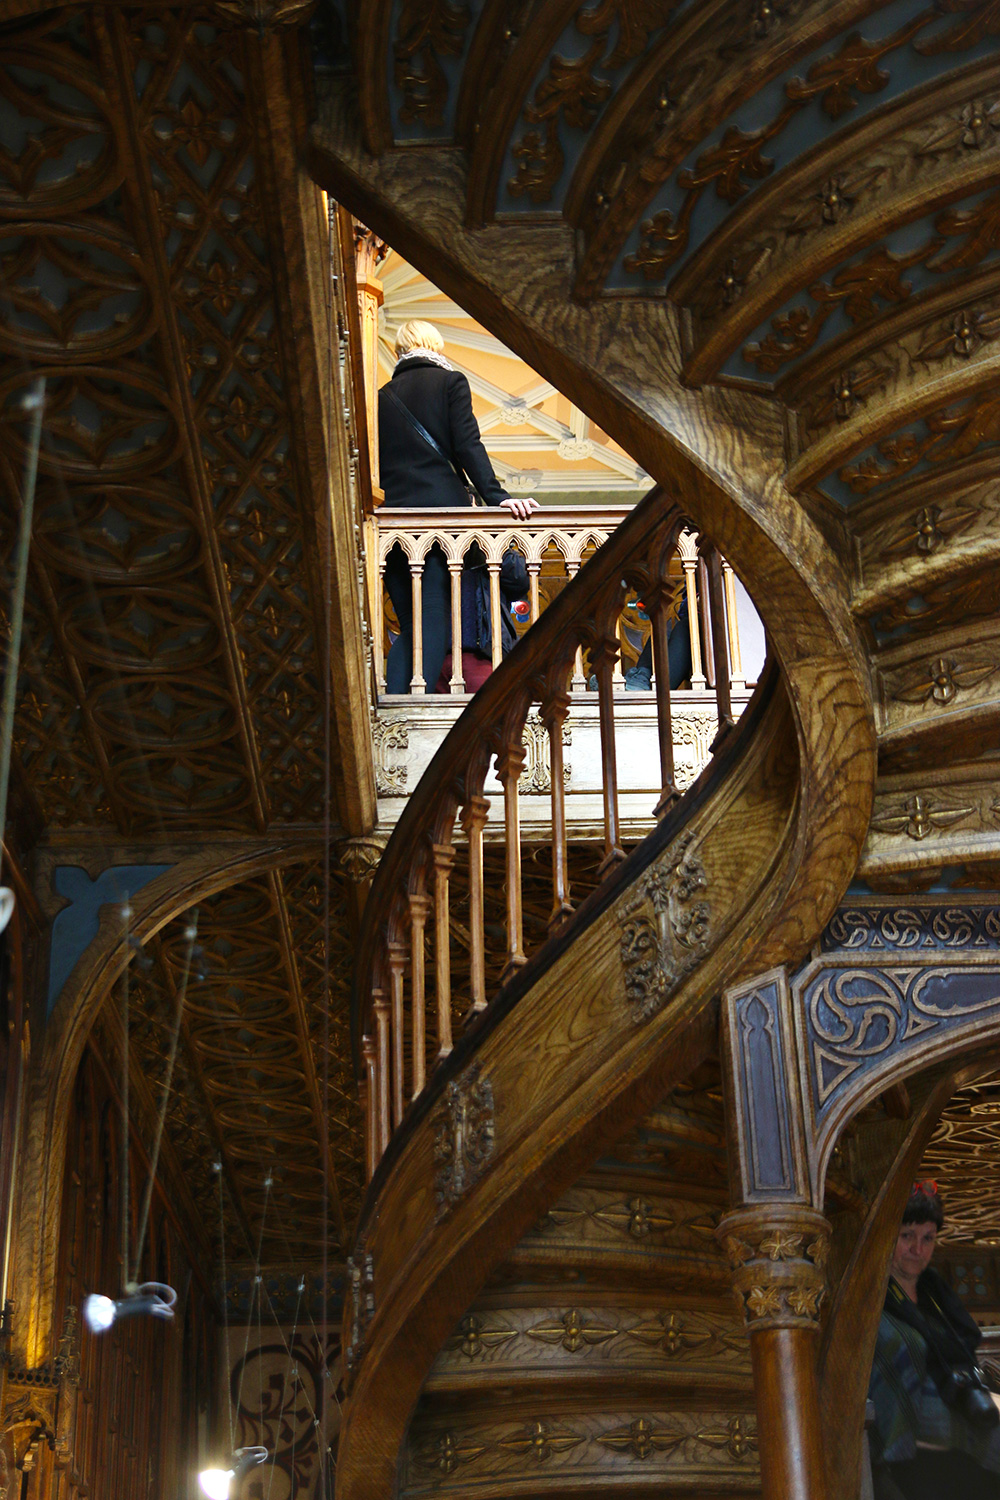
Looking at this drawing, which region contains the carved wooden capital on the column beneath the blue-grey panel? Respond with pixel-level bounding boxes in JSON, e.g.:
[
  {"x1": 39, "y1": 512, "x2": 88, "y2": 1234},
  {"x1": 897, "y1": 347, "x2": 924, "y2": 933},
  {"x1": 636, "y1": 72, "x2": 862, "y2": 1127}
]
[{"x1": 715, "y1": 1203, "x2": 831, "y2": 1334}]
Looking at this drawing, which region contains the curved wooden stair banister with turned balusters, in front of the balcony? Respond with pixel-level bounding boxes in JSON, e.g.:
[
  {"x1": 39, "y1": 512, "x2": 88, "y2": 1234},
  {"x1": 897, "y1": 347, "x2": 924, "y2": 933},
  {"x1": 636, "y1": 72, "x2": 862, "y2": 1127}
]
[{"x1": 354, "y1": 491, "x2": 746, "y2": 1166}]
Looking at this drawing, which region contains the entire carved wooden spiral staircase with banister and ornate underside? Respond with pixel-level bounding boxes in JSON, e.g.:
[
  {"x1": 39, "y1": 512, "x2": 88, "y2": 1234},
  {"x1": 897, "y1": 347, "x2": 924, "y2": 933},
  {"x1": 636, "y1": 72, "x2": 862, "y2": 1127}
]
[{"x1": 309, "y1": 0, "x2": 1000, "y2": 1500}]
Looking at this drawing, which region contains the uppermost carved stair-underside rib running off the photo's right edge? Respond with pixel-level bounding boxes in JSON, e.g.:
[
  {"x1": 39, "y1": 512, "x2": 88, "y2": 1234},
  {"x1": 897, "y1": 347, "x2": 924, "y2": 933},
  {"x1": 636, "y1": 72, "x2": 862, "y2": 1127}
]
[{"x1": 680, "y1": 57, "x2": 1000, "y2": 384}]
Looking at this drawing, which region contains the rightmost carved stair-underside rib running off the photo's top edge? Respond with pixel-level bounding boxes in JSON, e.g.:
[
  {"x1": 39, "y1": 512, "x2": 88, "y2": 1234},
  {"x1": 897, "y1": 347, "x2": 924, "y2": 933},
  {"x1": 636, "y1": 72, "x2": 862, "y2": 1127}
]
[{"x1": 564, "y1": 0, "x2": 883, "y2": 299}]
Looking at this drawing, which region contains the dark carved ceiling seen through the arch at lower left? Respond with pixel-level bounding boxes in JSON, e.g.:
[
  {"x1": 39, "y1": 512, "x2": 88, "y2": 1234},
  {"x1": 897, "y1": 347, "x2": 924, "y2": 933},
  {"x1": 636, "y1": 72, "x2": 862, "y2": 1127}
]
[{"x1": 97, "y1": 863, "x2": 363, "y2": 1272}]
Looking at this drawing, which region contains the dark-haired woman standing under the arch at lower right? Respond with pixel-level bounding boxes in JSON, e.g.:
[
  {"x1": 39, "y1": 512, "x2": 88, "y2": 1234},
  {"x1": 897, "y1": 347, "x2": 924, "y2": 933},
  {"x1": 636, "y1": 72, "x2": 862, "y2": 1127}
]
[{"x1": 868, "y1": 1182, "x2": 1000, "y2": 1500}]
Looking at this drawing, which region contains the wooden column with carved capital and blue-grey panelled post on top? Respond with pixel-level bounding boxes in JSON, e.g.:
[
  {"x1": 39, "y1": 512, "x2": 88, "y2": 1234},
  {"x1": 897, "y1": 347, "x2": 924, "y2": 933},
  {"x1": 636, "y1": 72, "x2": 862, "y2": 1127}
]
[{"x1": 717, "y1": 969, "x2": 831, "y2": 1500}]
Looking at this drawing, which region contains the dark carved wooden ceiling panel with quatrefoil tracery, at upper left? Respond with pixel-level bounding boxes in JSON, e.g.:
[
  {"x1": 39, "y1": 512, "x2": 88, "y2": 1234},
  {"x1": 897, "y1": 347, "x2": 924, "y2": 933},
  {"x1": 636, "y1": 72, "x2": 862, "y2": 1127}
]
[{"x1": 0, "y1": 8, "x2": 344, "y2": 833}]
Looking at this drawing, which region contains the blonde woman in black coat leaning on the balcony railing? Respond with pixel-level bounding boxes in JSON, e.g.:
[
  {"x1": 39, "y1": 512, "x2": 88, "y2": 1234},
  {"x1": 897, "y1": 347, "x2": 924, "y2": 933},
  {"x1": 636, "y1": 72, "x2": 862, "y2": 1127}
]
[{"x1": 378, "y1": 320, "x2": 538, "y2": 693}]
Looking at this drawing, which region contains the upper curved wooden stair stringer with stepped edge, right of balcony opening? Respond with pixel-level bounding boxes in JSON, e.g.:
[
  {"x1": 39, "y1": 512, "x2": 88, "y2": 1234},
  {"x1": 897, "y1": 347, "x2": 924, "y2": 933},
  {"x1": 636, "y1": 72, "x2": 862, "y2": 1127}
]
[{"x1": 307, "y1": 80, "x2": 876, "y2": 969}]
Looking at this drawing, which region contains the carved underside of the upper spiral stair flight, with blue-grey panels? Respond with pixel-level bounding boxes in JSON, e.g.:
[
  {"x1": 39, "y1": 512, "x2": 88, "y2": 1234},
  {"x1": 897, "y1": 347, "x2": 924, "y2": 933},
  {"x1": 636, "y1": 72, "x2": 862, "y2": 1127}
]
[{"x1": 338, "y1": 0, "x2": 1000, "y2": 885}]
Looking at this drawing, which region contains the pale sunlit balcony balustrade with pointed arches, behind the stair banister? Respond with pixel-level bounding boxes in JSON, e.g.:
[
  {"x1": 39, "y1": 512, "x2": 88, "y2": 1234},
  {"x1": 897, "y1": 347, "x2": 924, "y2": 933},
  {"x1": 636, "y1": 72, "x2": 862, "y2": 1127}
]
[{"x1": 366, "y1": 506, "x2": 757, "y2": 840}]
